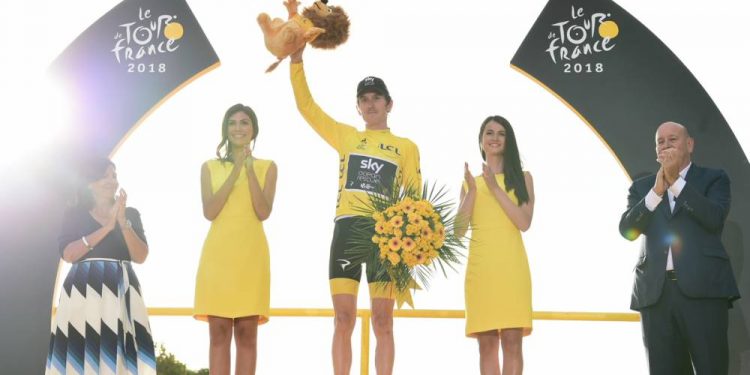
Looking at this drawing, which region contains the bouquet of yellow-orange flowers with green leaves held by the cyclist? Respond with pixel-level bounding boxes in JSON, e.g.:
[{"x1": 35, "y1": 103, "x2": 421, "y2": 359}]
[{"x1": 347, "y1": 183, "x2": 465, "y2": 293}]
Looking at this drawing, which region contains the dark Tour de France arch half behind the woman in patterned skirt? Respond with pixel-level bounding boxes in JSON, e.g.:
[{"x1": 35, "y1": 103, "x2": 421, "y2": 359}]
[{"x1": 0, "y1": 0, "x2": 219, "y2": 374}]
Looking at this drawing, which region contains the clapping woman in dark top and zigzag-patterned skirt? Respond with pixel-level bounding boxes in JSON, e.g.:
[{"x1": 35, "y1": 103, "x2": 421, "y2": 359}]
[{"x1": 46, "y1": 158, "x2": 156, "y2": 375}]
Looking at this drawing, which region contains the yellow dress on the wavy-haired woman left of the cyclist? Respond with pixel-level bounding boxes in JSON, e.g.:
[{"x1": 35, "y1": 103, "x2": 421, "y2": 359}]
[{"x1": 193, "y1": 160, "x2": 271, "y2": 324}]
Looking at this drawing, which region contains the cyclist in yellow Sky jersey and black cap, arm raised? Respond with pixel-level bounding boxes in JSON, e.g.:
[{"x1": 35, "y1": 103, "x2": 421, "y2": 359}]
[{"x1": 290, "y1": 48, "x2": 422, "y2": 375}]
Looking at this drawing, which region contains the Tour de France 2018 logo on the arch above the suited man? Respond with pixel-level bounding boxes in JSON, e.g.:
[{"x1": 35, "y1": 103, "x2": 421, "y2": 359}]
[{"x1": 546, "y1": 5, "x2": 620, "y2": 74}]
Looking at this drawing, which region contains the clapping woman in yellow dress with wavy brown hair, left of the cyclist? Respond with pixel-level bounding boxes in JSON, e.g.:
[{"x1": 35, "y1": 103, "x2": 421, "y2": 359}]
[{"x1": 193, "y1": 104, "x2": 277, "y2": 375}]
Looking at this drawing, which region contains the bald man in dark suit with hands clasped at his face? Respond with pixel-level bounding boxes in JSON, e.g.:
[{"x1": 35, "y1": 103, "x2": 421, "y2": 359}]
[{"x1": 620, "y1": 122, "x2": 739, "y2": 375}]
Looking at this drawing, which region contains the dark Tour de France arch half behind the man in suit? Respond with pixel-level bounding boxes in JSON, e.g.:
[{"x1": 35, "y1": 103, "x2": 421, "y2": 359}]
[{"x1": 511, "y1": 0, "x2": 750, "y2": 374}]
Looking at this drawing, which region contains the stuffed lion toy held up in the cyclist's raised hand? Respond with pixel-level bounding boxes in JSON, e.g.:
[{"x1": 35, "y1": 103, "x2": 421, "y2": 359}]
[{"x1": 258, "y1": 0, "x2": 349, "y2": 73}]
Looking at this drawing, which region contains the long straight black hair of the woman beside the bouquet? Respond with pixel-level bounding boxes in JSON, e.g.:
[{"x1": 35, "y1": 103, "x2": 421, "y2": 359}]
[{"x1": 479, "y1": 116, "x2": 529, "y2": 206}]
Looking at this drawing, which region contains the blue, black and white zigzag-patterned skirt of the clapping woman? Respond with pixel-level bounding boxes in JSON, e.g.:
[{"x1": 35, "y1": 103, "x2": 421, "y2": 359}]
[{"x1": 46, "y1": 259, "x2": 156, "y2": 375}]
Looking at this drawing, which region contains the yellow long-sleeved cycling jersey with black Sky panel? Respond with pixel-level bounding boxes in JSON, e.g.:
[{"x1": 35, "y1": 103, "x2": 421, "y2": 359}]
[{"x1": 290, "y1": 63, "x2": 422, "y2": 218}]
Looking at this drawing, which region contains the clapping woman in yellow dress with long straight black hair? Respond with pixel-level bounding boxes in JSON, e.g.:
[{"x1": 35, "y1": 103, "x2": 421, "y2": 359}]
[{"x1": 457, "y1": 116, "x2": 534, "y2": 375}]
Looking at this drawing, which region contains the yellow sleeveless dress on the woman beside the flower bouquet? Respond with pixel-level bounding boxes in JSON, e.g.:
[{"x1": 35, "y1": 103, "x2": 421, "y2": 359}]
[{"x1": 464, "y1": 174, "x2": 532, "y2": 337}]
